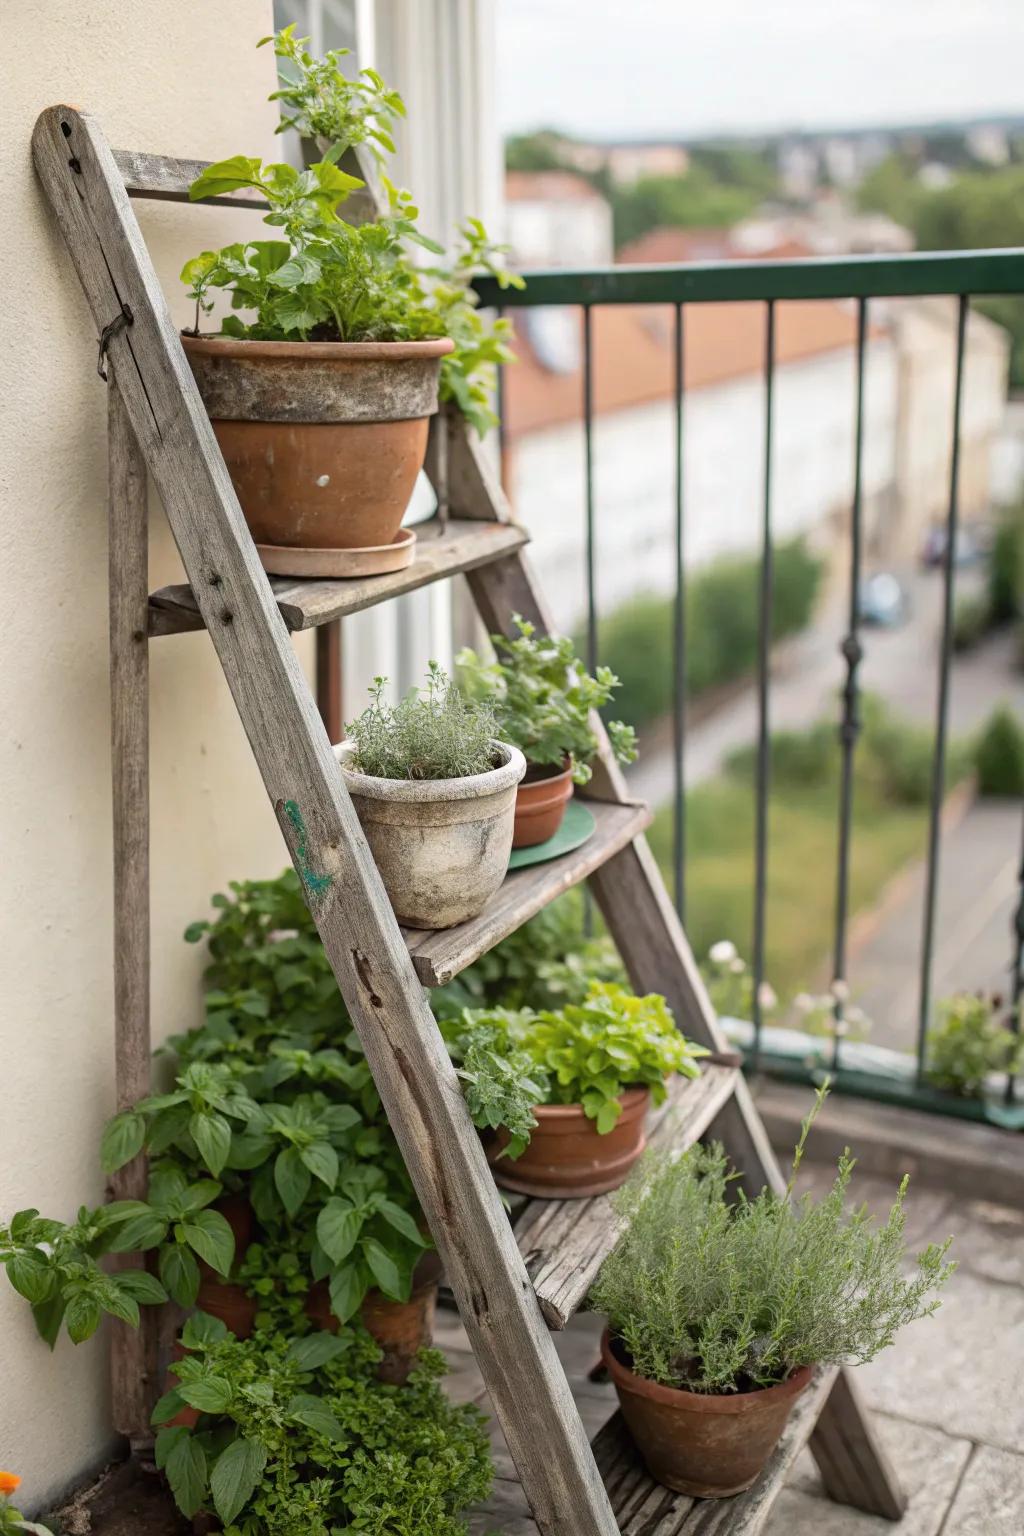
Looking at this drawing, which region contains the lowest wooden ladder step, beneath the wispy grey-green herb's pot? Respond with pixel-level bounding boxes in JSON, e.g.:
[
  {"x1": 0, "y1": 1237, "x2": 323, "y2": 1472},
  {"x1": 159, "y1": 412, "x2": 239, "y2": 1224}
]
[{"x1": 593, "y1": 1366, "x2": 837, "y2": 1536}]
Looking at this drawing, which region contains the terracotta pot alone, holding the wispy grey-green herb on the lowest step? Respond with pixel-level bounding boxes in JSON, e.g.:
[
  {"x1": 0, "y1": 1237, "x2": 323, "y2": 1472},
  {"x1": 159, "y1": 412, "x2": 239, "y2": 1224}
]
[{"x1": 600, "y1": 1330, "x2": 811, "y2": 1499}]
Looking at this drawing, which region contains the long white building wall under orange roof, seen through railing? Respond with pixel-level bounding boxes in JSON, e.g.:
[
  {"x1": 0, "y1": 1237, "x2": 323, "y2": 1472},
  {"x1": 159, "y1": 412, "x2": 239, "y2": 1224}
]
[{"x1": 511, "y1": 338, "x2": 897, "y2": 630}]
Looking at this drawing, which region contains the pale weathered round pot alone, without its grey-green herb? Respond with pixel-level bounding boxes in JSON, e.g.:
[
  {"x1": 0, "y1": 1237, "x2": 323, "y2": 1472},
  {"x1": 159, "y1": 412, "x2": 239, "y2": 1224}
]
[{"x1": 335, "y1": 742, "x2": 527, "y2": 928}]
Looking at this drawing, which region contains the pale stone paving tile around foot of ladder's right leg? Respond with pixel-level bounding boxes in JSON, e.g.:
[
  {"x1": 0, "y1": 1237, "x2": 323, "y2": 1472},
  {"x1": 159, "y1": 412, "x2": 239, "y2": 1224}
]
[{"x1": 765, "y1": 1413, "x2": 972, "y2": 1536}]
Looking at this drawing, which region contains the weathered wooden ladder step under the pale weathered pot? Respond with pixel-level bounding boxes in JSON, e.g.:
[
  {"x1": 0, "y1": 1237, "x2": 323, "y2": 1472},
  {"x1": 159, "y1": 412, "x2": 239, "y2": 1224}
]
[{"x1": 402, "y1": 800, "x2": 651, "y2": 986}]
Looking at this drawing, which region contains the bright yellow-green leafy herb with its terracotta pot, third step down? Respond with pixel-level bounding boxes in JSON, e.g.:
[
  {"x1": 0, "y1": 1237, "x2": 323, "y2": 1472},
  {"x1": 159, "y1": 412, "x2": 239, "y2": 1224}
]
[{"x1": 441, "y1": 982, "x2": 706, "y2": 1198}]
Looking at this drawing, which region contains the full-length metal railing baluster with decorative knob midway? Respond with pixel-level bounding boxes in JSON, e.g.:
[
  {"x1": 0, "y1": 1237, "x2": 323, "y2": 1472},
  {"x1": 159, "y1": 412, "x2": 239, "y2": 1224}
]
[{"x1": 832, "y1": 298, "x2": 867, "y2": 1071}]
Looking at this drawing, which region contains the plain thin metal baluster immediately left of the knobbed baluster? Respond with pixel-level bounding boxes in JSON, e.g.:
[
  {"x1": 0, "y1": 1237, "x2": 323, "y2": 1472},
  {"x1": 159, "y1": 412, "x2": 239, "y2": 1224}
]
[{"x1": 751, "y1": 300, "x2": 775, "y2": 1071}]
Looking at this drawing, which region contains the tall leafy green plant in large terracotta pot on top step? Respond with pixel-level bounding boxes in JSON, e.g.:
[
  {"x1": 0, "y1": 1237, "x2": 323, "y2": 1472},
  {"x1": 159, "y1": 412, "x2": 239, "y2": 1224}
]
[{"x1": 181, "y1": 28, "x2": 519, "y2": 576}]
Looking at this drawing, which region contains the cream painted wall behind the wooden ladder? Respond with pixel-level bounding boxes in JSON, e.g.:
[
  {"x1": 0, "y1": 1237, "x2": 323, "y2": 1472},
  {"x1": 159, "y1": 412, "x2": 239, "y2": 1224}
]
[{"x1": 0, "y1": 0, "x2": 316, "y2": 1510}]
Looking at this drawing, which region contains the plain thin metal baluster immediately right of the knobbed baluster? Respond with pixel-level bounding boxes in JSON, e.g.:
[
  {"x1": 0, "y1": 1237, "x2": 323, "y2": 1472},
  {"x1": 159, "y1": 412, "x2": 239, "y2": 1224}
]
[{"x1": 917, "y1": 293, "x2": 970, "y2": 1083}]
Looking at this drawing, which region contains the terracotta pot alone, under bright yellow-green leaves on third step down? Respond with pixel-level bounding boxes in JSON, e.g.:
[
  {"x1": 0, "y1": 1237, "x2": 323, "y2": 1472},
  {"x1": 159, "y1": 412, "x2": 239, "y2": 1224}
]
[{"x1": 487, "y1": 1087, "x2": 651, "y2": 1200}]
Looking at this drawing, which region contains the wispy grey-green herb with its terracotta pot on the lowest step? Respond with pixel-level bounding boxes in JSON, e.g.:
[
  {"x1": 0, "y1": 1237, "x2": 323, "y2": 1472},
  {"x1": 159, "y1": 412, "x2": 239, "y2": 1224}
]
[{"x1": 590, "y1": 1095, "x2": 955, "y2": 1498}]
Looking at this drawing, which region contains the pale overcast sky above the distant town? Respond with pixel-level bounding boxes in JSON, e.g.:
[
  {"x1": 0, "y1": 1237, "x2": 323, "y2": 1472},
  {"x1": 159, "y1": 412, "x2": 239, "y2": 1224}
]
[{"x1": 497, "y1": 0, "x2": 1024, "y2": 138}]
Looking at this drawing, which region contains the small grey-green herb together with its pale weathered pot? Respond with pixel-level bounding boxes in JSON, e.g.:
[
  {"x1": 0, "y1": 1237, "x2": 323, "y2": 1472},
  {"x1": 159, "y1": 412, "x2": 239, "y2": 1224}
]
[{"x1": 335, "y1": 662, "x2": 527, "y2": 928}]
